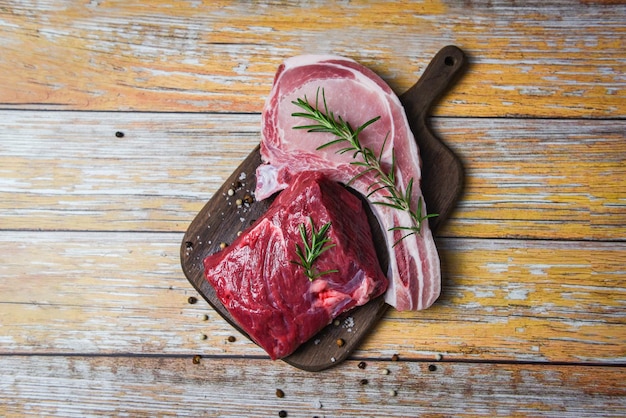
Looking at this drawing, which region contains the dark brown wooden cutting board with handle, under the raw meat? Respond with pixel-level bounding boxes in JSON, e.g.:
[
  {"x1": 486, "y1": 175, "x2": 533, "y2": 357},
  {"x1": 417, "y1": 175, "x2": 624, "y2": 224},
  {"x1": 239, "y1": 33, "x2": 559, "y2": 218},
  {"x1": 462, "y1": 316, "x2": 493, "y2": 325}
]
[{"x1": 180, "y1": 46, "x2": 467, "y2": 371}]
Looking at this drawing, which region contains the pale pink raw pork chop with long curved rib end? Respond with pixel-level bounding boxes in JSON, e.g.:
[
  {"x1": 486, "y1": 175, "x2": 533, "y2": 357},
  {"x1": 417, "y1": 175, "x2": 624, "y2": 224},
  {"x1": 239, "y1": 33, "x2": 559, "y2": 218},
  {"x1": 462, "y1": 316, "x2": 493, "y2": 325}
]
[{"x1": 256, "y1": 55, "x2": 441, "y2": 310}]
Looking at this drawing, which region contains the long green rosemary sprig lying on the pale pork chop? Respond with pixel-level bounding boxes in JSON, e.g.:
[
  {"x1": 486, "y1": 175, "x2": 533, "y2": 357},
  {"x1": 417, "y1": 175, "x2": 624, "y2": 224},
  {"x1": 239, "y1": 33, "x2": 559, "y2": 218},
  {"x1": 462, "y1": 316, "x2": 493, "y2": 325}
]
[{"x1": 291, "y1": 88, "x2": 438, "y2": 246}]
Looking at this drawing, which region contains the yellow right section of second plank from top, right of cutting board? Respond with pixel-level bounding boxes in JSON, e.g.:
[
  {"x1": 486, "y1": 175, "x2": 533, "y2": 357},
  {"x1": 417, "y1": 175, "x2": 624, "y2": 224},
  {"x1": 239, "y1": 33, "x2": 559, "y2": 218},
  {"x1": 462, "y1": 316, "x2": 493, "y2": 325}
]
[{"x1": 433, "y1": 118, "x2": 626, "y2": 240}]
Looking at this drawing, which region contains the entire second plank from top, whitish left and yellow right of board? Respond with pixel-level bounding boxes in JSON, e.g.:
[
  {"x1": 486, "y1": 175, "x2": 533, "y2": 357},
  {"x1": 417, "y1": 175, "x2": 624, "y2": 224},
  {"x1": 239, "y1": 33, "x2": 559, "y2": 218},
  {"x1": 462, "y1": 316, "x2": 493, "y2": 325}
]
[{"x1": 0, "y1": 111, "x2": 626, "y2": 240}]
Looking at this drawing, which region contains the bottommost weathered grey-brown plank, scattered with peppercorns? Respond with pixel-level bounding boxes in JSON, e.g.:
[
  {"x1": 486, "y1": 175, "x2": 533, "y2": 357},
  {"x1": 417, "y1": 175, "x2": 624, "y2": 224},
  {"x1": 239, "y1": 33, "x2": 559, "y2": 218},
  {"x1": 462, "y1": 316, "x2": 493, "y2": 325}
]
[{"x1": 0, "y1": 356, "x2": 626, "y2": 418}]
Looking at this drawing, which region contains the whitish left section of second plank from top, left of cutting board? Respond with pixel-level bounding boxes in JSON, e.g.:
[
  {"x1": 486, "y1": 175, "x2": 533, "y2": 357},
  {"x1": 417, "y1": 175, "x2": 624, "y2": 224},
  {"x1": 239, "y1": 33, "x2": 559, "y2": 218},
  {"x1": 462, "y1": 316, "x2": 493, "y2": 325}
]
[{"x1": 0, "y1": 111, "x2": 260, "y2": 231}]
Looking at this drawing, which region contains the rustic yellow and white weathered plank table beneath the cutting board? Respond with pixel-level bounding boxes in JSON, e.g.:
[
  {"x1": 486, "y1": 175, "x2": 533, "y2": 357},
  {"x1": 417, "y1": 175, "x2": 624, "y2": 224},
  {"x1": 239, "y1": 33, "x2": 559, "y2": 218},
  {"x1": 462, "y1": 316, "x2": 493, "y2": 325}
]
[{"x1": 0, "y1": 0, "x2": 626, "y2": 417}]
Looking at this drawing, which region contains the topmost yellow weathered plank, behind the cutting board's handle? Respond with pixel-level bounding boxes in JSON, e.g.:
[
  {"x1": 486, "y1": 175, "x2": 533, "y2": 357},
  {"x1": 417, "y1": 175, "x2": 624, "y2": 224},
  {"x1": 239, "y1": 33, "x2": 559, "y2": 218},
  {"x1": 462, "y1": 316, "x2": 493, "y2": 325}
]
[{"x1": 0, "y1": 0, "x2": 626, "y2": 118}]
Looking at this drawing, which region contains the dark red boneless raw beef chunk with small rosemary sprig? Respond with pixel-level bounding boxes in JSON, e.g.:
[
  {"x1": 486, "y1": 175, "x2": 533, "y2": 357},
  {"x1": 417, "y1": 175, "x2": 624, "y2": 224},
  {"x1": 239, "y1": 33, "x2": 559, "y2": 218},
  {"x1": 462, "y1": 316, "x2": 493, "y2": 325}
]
[{"x1": 204, "y1": 172, "x2": 387, "y2": 359}]
